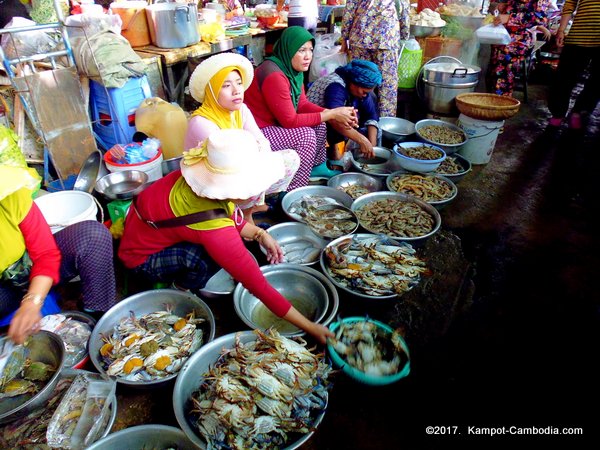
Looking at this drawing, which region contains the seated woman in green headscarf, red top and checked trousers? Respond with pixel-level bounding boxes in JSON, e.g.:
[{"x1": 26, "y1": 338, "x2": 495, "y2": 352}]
[{"x1": 244, "y1": 27, "x2": 357, "y2": 191}]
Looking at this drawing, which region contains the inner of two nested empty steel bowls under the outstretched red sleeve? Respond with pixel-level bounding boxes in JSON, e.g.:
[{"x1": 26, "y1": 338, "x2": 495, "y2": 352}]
[{"x1": 233, "y1": 264, "x2": 329, "y2": 336}]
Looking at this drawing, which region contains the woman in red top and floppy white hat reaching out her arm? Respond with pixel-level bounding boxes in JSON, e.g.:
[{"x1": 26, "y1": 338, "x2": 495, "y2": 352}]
[{"x1": 119, "y1": 129, "x2": 332, "y2": 343}]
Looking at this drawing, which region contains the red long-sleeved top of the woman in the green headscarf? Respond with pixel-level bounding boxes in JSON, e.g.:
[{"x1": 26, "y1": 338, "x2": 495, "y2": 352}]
[{"x1": 244, "y1": 72, "x2": 324, "y2": 128}]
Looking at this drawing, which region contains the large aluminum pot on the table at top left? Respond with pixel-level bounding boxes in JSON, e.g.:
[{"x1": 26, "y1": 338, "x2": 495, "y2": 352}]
[{"x1": 146, "y1": 3, "x2": 200, "y2": 48}]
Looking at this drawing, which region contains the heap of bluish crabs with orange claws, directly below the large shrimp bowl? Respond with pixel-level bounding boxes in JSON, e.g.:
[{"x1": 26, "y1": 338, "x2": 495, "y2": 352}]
[{"x1": 325, "y1": 235, "x2": 430, "y2": 297}]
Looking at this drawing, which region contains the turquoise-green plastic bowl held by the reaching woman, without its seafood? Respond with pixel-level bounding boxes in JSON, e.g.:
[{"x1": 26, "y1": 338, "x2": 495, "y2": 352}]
[{"x1": 327, "y1": 317, "x2": 410, "y2": 386}]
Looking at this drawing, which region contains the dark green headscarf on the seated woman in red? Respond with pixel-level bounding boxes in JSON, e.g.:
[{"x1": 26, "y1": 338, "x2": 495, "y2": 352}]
[{"x1": 267, "y1": 26, "x2": 315, "y2": 108}]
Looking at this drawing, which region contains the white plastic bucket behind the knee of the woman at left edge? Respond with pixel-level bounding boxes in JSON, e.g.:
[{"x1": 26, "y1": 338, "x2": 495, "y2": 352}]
[{"x1": 34, "y1": 191, "x2": 98, "y2": 234}]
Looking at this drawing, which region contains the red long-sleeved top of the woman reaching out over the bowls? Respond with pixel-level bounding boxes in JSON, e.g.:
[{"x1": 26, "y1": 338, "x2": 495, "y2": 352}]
[{"x1": 118, "y1": 170, "x2": 291, "y2": 317}]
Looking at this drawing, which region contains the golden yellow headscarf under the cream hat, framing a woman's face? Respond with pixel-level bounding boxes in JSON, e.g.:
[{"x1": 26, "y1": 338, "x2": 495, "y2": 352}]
[{"x1": 192, "y1": 66, "x2": 244, "y2": 129}]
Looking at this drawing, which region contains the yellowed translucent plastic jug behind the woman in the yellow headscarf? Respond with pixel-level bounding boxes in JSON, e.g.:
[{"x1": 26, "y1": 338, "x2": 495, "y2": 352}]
[{"x1": 135, "y1": 97, "x2": 187, "y2": 159}]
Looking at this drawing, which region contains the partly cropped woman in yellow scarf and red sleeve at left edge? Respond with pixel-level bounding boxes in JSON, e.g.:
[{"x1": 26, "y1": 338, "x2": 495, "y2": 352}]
[{"x1": 0, "y1": 164, "x2": 116, "y2": 343}]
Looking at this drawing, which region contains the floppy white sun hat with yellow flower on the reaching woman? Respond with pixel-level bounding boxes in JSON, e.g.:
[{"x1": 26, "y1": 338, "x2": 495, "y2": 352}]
[{"x1": 181, "y1": 128, "x2": 285, "y2": 200}]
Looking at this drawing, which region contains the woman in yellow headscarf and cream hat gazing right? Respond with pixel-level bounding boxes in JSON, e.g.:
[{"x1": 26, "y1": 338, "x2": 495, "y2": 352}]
[{"x1": 184, "y1": 53, "x2": 300, "y2": 223}]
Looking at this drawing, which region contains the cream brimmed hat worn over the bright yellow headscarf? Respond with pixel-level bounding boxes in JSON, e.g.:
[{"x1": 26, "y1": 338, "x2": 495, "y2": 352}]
[{"x1": 190, "y1": 53, "x2": 254, "y2": 103}]
